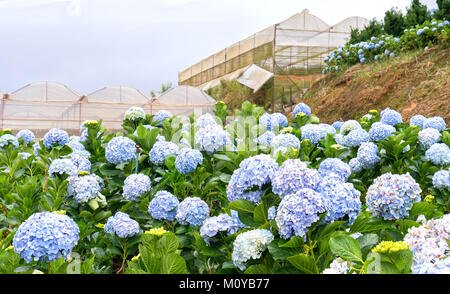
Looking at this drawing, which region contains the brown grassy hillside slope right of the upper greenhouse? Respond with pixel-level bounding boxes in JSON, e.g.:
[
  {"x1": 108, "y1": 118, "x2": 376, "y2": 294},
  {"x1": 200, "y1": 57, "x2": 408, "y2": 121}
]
[{"x1": 299, "y1": 46, "x2": 450, "y2": 123}]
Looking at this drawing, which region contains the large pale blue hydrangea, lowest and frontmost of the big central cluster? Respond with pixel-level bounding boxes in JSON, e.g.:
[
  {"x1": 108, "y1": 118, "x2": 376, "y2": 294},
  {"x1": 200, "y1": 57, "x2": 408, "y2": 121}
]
[{"x1": 275, "y1": 188, "x2": 330, "y2": 239}]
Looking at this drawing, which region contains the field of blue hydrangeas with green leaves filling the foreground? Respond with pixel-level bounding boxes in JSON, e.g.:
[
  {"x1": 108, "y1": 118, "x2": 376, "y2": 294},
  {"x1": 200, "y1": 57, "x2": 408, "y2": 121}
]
[{"x1": 0, "y1": 102, "x2": 450, "y2": 274}]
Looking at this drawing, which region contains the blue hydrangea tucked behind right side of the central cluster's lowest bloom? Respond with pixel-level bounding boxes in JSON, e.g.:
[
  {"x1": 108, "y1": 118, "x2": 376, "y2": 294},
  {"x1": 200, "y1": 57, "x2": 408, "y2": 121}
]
[{"x1": 317, "y1": 179, "x2": 361, "y2": 224}]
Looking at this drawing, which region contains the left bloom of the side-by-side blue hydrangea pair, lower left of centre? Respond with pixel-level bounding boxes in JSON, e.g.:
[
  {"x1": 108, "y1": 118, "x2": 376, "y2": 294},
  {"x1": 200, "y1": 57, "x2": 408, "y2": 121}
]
[{"x1": 148, "y1": 191, "x2": 180, "y2": 221}]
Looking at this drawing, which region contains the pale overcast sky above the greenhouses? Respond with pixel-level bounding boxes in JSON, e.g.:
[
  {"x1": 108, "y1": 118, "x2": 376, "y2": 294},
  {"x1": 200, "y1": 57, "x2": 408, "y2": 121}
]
[{"x1": 0, "y1": 0, "x2": 436, "y2": 94}]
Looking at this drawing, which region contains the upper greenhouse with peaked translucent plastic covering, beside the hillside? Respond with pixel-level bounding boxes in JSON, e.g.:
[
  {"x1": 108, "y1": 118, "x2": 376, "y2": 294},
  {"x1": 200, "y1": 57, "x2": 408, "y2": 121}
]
[{"x1": 178, "y1": 9, "x2": 369, "y2": 89}]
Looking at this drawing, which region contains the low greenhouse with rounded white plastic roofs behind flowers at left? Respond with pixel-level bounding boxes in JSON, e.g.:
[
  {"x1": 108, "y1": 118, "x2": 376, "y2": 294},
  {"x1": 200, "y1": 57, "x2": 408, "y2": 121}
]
[{"x1": 0, "y1": 81, "x2": 216, "y2": 137}]
